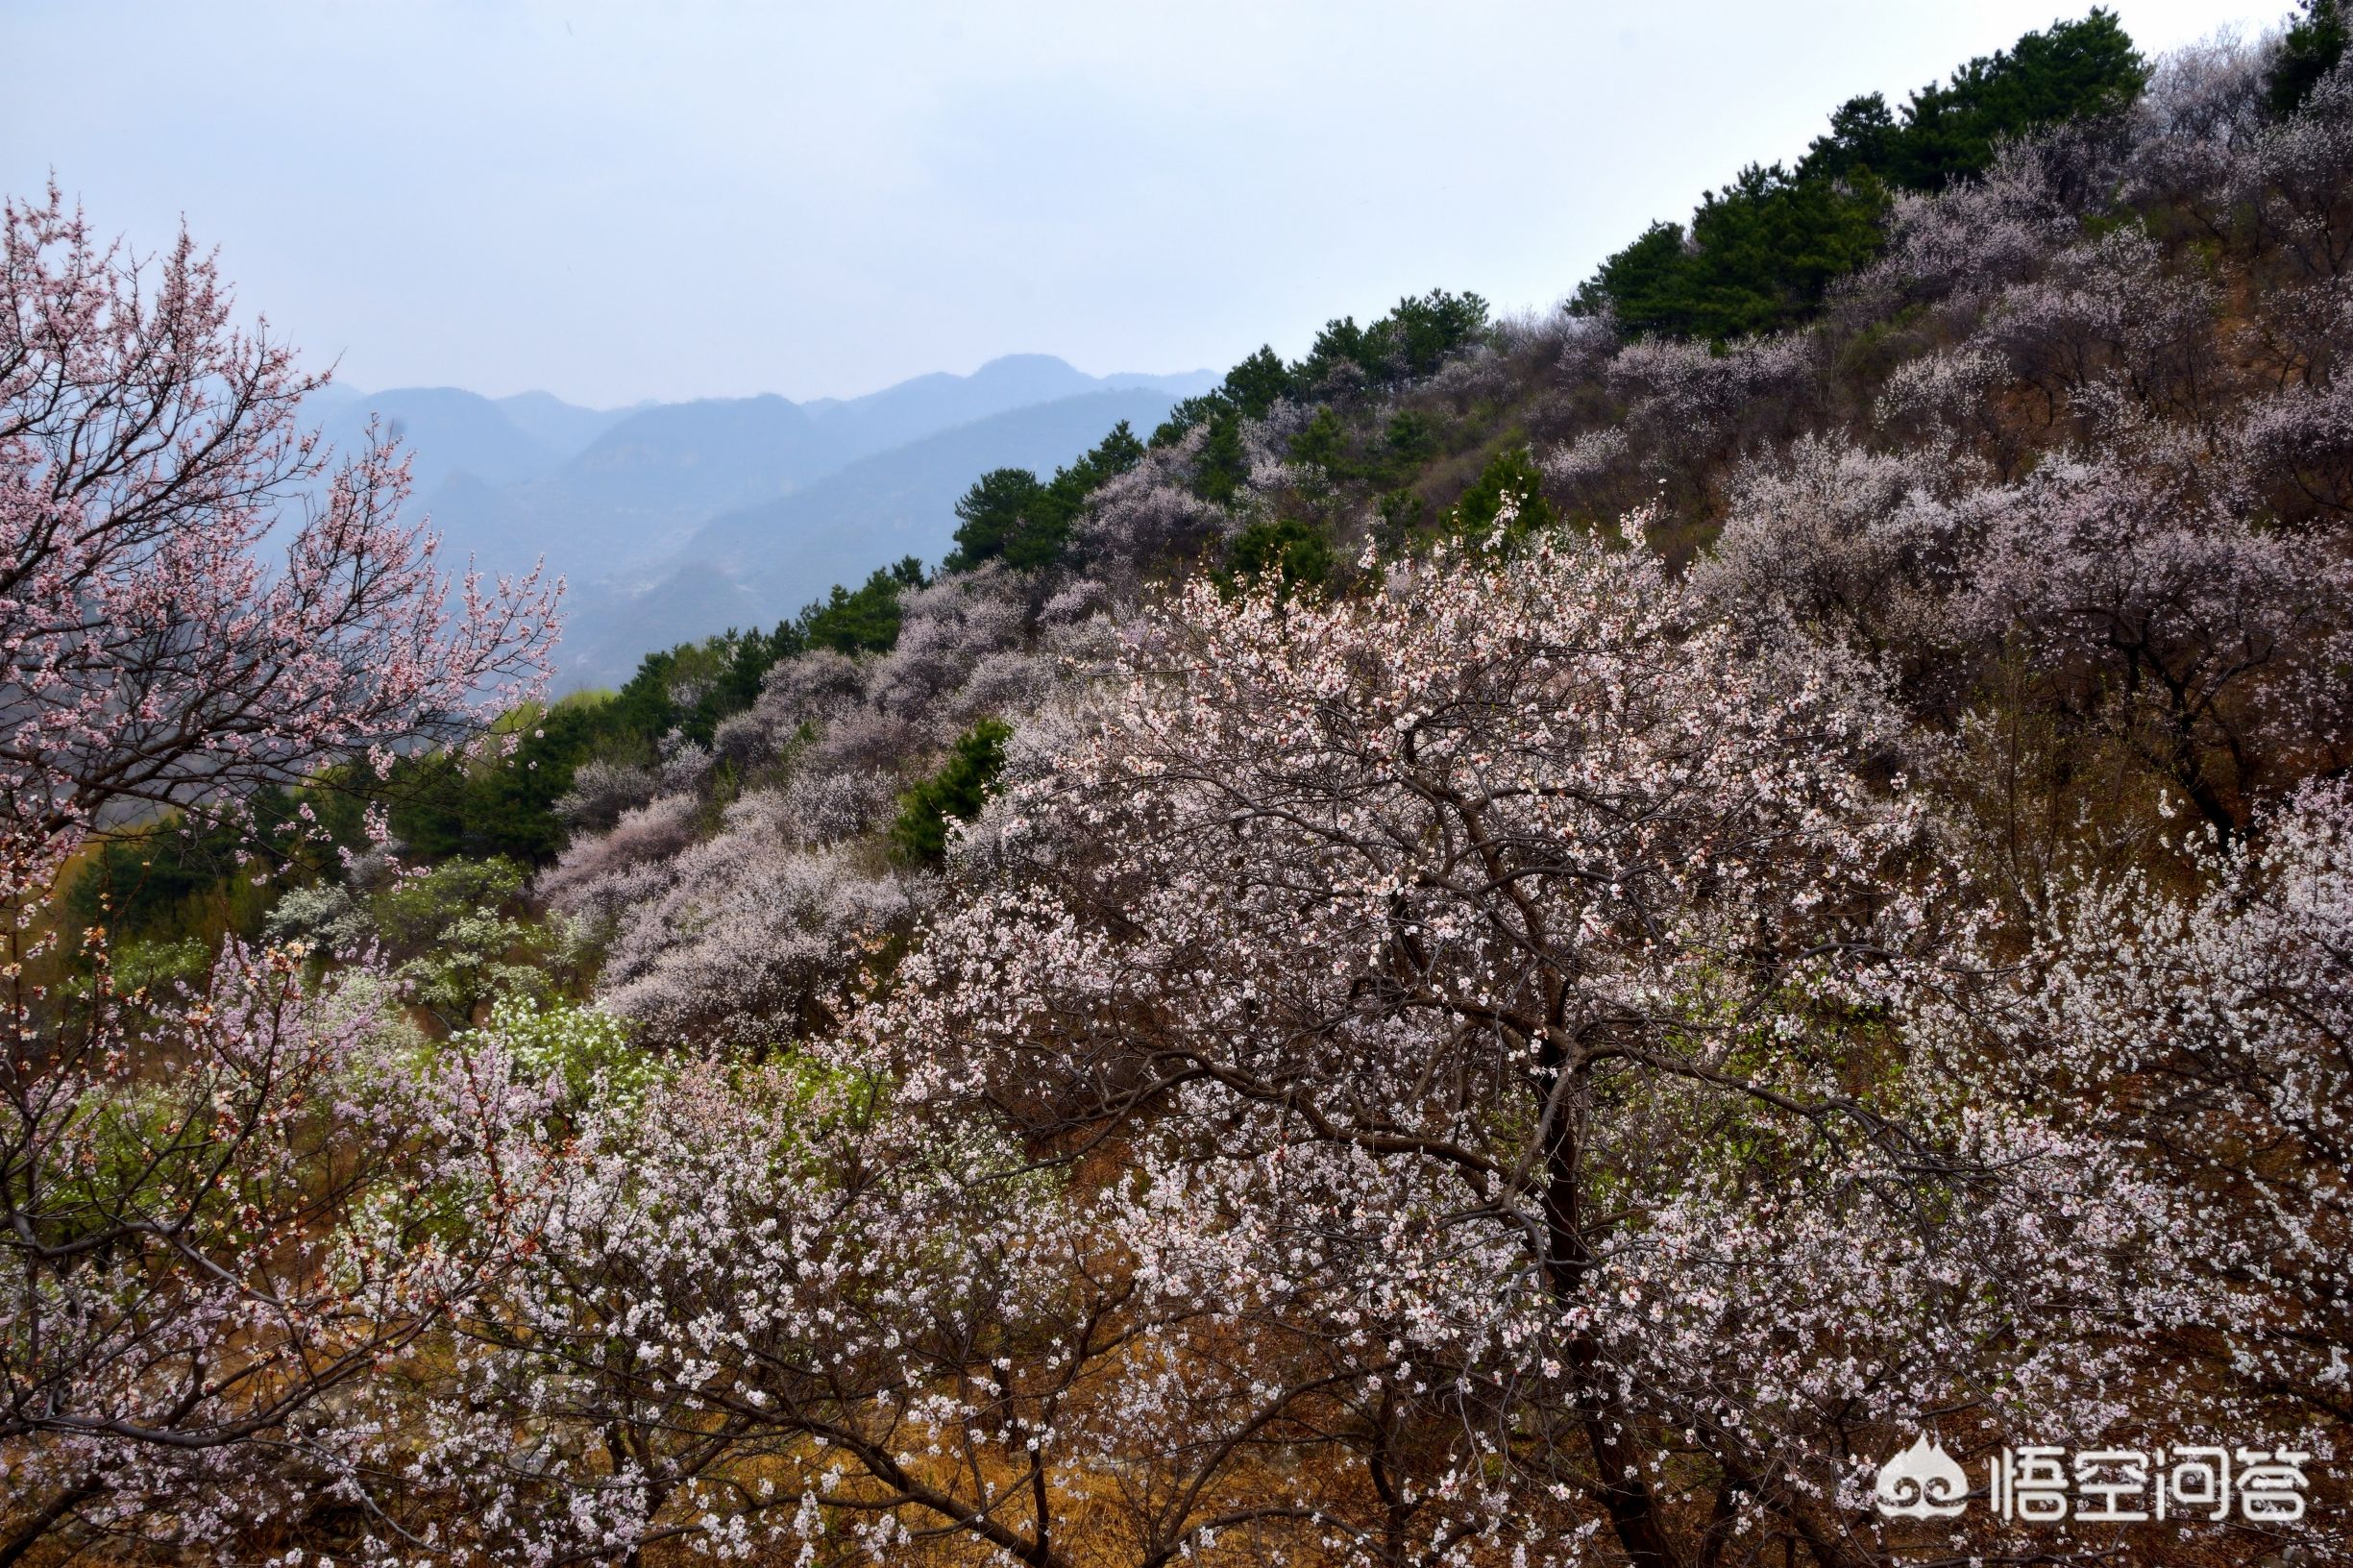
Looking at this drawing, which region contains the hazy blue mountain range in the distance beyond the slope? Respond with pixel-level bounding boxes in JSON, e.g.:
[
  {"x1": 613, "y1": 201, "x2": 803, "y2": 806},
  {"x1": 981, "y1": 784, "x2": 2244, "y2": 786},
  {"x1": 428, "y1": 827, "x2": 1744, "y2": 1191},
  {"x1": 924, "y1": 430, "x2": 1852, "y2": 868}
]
[{"x1": 315, "y1": 354, "x2": 1216, "y2": 690}]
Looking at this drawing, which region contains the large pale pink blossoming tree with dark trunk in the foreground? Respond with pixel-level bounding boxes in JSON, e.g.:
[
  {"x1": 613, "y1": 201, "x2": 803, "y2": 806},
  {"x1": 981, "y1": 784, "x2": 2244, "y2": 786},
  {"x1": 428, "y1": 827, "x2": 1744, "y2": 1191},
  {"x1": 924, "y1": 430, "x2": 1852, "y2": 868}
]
[{"x1": 866, "y1": 542, "x2": 2195, "y2": 1566}]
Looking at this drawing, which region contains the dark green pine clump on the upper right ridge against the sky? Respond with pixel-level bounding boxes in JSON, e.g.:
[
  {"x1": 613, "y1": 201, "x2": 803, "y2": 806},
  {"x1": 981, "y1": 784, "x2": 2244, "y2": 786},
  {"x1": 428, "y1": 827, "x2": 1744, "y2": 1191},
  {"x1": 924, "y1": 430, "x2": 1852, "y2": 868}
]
[{"x1": 1569, "y1": 10, "x2": 2148, "y2": 341}]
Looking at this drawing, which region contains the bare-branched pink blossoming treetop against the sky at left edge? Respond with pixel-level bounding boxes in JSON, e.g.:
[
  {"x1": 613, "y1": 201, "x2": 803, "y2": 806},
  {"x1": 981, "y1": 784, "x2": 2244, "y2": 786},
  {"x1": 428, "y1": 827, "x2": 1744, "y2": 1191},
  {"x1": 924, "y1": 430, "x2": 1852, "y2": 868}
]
[{"x1": 0, "y1": 188, "x2": 555, "y2": 870}]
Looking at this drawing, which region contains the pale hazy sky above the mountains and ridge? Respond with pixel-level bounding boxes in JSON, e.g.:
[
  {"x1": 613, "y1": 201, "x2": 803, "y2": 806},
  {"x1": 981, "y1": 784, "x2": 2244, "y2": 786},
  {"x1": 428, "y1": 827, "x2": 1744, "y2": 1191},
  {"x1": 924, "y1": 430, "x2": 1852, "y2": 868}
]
[{"x1": 0, "y1": 0, "x2": 2285, "y2": 403}]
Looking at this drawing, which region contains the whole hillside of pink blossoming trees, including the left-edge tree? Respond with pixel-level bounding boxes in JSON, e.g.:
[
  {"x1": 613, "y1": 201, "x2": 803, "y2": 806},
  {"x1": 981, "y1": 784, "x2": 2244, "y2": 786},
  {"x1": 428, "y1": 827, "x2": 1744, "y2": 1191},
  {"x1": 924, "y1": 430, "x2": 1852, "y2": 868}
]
[{"x1": 0, "y1": 0, "x2": 2353, "y2": 1568}]
